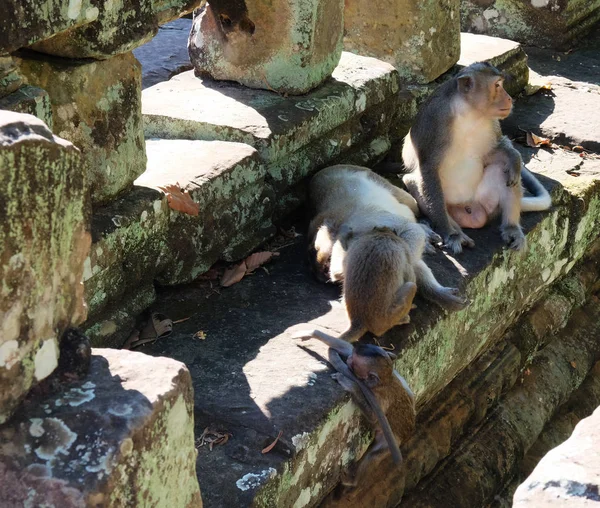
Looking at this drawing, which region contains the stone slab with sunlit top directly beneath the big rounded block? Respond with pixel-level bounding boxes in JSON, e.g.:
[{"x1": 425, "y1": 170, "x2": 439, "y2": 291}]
[{"x1": 142, "y1": 53, "x2": 400, "y2": 167}]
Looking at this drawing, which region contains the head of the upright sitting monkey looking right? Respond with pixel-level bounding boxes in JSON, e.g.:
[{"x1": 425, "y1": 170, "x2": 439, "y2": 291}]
[{"x1": 457, "y1": 62, "x2": 512, "y2": 120}]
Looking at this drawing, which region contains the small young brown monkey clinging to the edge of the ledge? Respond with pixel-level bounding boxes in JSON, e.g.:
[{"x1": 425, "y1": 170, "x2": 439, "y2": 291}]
[{"x1": 295, "y1": 330, "x2": 415, "y2": 487}]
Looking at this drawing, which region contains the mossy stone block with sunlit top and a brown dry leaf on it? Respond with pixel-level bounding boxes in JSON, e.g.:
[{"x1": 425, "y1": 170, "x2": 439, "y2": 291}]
[{"x1": 84, "y1": 140, "x2": 273, "y2": 341}]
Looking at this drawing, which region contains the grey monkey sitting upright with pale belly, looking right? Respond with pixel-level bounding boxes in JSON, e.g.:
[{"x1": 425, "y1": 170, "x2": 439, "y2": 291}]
[{"x1": 402, "y1": 62, "x2": 551, "y2": 254}]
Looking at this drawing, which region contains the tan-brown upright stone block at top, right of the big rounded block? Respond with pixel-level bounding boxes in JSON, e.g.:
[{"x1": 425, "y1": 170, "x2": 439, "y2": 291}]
[{"x1": 344, "y1": 0, "x2": 461, "y2": 83}]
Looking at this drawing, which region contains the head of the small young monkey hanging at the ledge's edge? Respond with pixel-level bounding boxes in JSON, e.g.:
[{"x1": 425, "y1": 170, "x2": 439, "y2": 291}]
[{"x1": 346, "y1": 343, "x2": 396, "y2": 389}]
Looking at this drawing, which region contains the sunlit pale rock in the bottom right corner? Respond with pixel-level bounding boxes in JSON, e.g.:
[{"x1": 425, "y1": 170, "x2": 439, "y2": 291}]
[{"x1": 513, "y1": 402, "x2": 600, "y2": 508}]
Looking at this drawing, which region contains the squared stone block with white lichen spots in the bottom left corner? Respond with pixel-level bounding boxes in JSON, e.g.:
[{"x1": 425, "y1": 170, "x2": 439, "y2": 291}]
[{"x1": 0, "y1": 349, "x2": 202, "y2": 508}]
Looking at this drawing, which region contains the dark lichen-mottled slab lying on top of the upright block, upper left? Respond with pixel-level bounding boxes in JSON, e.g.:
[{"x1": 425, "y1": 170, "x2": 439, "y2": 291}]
[{"x1": 33, "y1": 0, "x2": 205, "y2": 59}]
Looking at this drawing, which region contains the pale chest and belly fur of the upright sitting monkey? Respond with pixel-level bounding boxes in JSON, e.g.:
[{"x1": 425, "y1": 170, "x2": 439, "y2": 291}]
[{"x1": 439, "y1": 115, "x2": 496, "y2": 205}]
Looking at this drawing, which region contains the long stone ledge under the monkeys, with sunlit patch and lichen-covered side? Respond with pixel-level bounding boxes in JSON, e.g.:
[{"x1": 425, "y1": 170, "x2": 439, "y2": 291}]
[{"x1": 134, "y1": 141, "x2": 600, "y2": 507}]
